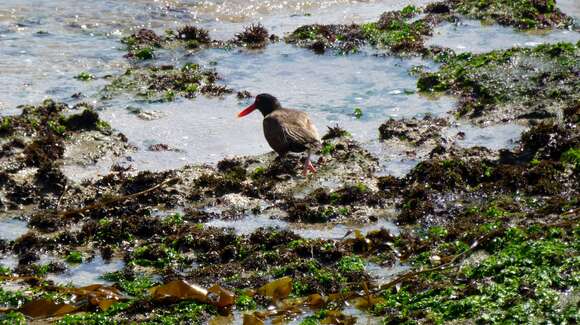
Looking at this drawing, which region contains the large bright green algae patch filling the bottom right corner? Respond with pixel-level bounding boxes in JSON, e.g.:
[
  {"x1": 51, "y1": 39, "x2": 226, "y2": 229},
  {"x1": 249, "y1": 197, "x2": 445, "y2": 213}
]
[{"x1": 375, "y1": 226, "x2": 580, "y2": 323}]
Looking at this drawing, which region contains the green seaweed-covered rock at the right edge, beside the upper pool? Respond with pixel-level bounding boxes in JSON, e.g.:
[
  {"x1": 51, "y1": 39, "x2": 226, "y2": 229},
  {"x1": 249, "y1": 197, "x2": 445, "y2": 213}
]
[{"x1": 417, "y1": 43, "x2": 580, "y2": 122}]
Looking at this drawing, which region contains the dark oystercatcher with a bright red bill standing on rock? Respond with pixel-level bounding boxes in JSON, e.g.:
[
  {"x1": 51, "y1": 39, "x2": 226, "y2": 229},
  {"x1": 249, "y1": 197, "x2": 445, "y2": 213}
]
[{"x1": 238, "y1": 94, "x2": 322, "y2": 176}]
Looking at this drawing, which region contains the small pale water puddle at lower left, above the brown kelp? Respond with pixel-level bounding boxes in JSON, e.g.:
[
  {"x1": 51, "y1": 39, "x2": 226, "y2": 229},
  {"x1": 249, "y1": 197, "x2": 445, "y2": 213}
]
[{"x1": 46, "y1": 256, "x2": 125, "y2": 287}]
